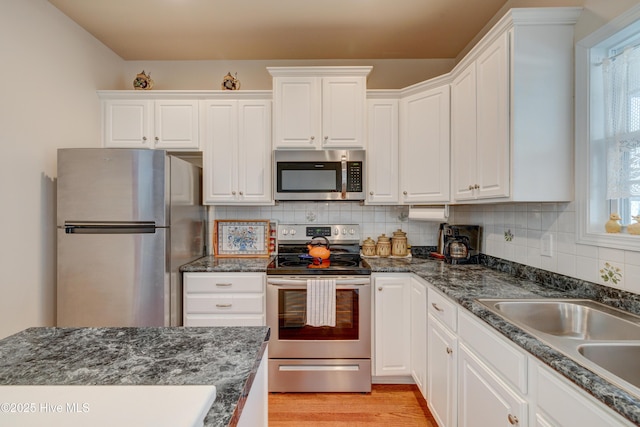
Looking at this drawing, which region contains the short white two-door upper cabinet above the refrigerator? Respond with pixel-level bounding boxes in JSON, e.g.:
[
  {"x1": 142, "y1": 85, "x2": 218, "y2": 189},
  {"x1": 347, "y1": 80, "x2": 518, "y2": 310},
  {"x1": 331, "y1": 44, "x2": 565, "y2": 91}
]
[{"x1": 101, "y1": 92, "x2": 200, "y2": 151}]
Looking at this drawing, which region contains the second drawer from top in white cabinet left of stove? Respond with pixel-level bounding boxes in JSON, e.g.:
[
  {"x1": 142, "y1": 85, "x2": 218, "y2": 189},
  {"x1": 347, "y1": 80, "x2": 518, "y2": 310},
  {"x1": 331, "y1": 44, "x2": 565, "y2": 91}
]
[{"x1": 185, "y1": 294, "x2": 264, "y2": 314}]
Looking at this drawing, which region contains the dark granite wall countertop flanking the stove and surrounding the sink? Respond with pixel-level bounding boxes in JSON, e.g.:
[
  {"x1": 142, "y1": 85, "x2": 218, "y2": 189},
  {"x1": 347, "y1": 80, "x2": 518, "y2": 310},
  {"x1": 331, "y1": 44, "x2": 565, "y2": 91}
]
[{"x1": 182, "y1": 251, "x2": 640, "y2": 425}]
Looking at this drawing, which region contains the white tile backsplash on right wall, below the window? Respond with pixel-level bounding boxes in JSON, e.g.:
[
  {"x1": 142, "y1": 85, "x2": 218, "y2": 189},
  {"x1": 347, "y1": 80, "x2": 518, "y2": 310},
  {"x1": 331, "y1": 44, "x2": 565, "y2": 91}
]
[{"x1": 449, "y1": 203, "x2": 640, "y2": 294}]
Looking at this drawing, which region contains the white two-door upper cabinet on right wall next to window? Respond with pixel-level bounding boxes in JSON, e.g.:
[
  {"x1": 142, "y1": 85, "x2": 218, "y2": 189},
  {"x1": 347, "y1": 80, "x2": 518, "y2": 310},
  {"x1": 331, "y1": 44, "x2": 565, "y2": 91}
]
[{"x1": 451, "y1": 8, "x2": 581, "y2": 202}]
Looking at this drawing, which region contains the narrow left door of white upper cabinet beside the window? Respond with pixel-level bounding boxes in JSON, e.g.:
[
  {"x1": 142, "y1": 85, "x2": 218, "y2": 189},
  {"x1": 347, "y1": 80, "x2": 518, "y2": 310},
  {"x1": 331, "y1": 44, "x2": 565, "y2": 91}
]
[{"x1": 451, "y1": 62, "x2": 477, "y2": 200}]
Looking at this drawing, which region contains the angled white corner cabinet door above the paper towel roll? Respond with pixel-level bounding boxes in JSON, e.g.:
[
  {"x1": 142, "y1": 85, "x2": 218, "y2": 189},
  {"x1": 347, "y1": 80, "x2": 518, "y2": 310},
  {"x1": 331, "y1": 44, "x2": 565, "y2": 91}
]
[{"x1": 400, "y1": 85, "x2": 450, "y2": 203}]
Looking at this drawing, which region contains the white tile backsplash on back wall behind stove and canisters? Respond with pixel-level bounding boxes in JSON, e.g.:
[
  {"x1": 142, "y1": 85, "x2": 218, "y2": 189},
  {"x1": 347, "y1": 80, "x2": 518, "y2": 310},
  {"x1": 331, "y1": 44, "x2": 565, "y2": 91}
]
[{"x1": 209, "y1": 202, "x2": 438, "y2": 246}]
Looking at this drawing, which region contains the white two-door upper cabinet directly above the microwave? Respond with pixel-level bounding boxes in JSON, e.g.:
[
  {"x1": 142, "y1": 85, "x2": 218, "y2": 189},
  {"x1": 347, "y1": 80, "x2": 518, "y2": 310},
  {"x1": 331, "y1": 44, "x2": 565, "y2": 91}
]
[{"x1": 267, "y1": 67, "x2": 371, "y2": 150}]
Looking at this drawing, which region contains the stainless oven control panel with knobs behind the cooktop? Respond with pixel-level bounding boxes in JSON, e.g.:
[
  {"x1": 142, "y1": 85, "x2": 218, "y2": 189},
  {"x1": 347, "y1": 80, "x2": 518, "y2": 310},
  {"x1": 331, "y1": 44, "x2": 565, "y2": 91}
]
[{"x1": 278, "y1": 224, "x2": 361, "y2": 243}]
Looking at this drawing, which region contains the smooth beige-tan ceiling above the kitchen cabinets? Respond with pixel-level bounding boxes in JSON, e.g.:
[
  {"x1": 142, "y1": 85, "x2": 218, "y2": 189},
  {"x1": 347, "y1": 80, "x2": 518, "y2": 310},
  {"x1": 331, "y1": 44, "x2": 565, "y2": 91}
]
[{"x1": 49, "y1": 0, "x2": 507, "y2": 60}]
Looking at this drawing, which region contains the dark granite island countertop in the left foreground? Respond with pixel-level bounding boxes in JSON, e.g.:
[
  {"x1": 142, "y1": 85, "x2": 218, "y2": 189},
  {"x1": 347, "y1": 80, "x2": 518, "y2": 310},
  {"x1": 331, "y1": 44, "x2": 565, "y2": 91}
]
[{"x1": 0, "y1": 327, "x2": 269, "y2": 427}]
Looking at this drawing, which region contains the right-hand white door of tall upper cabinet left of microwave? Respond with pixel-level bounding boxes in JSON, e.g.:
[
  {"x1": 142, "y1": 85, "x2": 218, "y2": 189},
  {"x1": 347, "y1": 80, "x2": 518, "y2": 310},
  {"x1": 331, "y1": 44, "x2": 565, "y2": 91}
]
[{"x1": 238, "y1": 100, "x2": 272, "y2": 203}]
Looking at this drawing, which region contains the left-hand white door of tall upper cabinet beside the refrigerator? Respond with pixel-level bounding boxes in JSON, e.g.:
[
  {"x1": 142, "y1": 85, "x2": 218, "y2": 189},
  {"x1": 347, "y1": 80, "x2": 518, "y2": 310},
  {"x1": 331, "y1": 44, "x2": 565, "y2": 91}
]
[{"x1": 202, "y1": 101, "x2": 239, "y2": 203}]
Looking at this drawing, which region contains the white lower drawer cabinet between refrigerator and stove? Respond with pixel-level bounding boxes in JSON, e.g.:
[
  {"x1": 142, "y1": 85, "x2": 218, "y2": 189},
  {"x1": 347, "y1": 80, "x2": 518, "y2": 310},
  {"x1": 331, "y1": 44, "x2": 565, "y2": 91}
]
[{"x1": 183, "y1": 273, "x2": 266, "y2": 326}]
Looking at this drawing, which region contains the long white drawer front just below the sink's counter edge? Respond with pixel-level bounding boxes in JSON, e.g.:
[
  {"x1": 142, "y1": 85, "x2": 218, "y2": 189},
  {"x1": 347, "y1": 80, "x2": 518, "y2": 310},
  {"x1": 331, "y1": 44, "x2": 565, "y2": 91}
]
[{"x1": 458, "y1": 310, "x2": 527, "y2": 393}]
